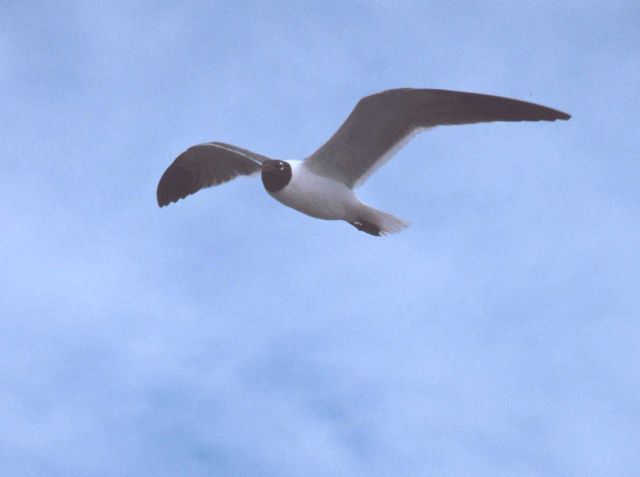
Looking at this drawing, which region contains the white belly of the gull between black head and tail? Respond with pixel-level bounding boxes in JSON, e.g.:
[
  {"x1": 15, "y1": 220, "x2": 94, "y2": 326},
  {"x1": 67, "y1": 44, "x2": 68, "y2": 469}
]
[{"x1": 270, "y1": 168, "x2": 357, "y2": 220}]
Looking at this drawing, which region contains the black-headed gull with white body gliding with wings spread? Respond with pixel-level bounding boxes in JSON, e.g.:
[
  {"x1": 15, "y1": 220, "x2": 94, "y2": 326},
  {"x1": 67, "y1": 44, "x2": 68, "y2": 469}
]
[{"x1": 157, "y1": 88, "x2": 571, "y2": 236}]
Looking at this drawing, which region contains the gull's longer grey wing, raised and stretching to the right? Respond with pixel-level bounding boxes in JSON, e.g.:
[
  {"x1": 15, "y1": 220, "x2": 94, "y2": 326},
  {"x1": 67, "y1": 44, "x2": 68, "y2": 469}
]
[{"x1": 305, "y1": 88, "x2": 571, "y2": 187}]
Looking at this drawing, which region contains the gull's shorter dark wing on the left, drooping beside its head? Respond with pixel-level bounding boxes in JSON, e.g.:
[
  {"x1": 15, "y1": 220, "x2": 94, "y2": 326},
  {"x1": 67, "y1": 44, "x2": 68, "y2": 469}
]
[{"x1": 157, "y1": 142, "x2": 269, "y2": 207}]
